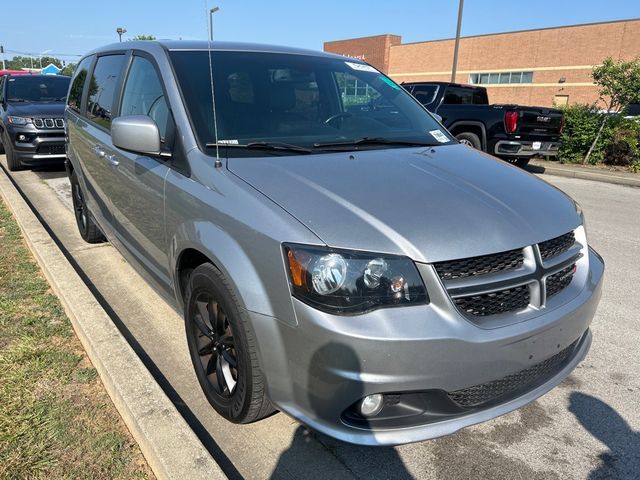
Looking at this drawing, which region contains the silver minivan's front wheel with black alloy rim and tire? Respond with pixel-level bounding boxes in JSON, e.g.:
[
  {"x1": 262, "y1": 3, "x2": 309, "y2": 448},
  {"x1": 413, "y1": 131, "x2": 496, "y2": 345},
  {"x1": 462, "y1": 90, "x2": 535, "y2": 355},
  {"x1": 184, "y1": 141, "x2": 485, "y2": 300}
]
[{"x1": 185, "y1": 263, "x2": 274, "y2": 423}]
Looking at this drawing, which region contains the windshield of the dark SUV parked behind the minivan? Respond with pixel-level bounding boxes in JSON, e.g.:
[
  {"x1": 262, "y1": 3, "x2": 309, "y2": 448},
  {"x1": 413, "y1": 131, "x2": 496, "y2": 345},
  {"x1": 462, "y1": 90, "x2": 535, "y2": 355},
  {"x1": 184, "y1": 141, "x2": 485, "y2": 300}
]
[{"x1": 6, "y1": 75, "x2": 70, "y2": 102}]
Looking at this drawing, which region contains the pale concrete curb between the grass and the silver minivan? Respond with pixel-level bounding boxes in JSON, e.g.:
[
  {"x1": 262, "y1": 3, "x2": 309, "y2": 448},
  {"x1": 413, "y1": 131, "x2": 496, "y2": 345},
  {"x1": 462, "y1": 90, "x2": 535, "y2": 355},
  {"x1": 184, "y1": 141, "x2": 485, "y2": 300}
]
[{"x1": 0, "y1": 168, "x2": 226, "y2": 480}]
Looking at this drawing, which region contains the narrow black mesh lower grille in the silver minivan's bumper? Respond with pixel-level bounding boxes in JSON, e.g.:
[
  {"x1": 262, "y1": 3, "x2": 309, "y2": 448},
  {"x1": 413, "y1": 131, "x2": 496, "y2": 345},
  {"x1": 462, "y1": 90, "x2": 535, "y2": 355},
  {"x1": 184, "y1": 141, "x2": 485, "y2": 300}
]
[{"x1": 448, "y1": 340, "x2": 578, "y2": 408}]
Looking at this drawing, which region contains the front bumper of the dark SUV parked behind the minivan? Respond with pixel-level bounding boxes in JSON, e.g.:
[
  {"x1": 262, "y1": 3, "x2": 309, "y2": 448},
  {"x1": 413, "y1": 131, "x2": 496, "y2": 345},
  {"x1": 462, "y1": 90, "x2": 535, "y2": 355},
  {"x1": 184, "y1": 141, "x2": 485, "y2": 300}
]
[{"x1": 7, "y1": 124, "x2": 66, "y2": 167}]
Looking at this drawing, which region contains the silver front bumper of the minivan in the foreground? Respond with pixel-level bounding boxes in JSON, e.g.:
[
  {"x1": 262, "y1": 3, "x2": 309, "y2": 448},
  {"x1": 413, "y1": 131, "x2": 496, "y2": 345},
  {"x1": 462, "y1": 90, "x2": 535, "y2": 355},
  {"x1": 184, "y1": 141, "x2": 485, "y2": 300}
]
[{"x1": 251, "y1": 249, "x2": 604, "y2": 445}]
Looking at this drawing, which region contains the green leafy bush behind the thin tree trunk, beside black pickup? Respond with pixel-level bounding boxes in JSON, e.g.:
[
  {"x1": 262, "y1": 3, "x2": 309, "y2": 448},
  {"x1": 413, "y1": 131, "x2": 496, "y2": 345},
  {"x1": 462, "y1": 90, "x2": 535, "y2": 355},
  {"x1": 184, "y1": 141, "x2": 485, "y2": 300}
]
[{"x1": 559, "y1": 105, "x2": 640, "y2": 166}]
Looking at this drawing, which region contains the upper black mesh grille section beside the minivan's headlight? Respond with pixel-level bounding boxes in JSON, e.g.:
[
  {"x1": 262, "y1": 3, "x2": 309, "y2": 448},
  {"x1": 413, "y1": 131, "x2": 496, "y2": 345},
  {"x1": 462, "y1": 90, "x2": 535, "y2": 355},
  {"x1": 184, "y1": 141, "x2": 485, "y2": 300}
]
[{"x1": 434, "y1": 249, "x2": 524, "y2": 280}]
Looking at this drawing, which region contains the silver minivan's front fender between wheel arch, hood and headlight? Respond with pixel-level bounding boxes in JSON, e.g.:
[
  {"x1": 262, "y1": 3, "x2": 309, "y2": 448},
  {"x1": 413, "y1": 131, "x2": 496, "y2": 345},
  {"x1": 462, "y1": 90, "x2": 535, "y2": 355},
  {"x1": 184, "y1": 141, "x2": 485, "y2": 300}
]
[{"x1": 165, "y1": 150, "x2": 320, "y2": 324}]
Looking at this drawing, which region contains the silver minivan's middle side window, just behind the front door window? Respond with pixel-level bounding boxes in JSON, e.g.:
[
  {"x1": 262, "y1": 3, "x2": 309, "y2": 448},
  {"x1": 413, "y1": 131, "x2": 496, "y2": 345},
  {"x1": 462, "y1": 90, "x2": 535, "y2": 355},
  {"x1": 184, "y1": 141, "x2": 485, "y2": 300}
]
[{"x1": 87, "y1": 55, "x2": 125, "y2": 129}]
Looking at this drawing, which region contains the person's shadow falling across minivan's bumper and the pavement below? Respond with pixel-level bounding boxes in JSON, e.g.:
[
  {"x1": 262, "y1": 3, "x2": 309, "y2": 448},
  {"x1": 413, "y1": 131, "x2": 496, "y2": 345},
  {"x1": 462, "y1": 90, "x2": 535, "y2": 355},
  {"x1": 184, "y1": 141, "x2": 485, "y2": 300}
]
[{"x1": 271, "y1": 342, "x2": 414, "y2": 480}]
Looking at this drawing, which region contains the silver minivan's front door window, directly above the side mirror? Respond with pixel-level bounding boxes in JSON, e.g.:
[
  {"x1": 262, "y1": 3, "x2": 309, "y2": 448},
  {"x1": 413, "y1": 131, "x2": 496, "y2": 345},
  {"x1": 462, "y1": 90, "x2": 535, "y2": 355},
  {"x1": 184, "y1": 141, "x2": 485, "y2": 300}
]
[{"x1": 120, "y1": 57, "x2": 169, "y2": 139}]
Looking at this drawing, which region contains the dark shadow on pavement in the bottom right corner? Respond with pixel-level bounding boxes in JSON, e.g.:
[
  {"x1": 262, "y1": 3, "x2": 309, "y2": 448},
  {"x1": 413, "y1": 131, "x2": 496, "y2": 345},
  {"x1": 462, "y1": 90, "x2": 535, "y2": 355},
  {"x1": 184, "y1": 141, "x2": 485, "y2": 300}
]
[{"x1": 569, "y1": 392, "x2": 640, "y2": 480}]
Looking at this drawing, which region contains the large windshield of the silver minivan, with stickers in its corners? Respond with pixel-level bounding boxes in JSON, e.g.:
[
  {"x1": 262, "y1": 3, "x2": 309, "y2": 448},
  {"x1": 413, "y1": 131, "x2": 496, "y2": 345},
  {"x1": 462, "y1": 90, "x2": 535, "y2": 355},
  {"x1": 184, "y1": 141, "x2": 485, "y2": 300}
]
[{"x1": 170, "y1": 51, "x2": 453, "y2": 156}]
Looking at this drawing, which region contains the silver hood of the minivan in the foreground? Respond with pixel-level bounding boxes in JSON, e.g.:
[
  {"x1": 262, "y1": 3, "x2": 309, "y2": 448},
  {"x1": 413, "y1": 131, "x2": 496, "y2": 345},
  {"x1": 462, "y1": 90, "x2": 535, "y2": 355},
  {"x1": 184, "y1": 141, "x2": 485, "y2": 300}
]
[{"x1": 228, "y1": 145, "x2": 580, "y2": 262}]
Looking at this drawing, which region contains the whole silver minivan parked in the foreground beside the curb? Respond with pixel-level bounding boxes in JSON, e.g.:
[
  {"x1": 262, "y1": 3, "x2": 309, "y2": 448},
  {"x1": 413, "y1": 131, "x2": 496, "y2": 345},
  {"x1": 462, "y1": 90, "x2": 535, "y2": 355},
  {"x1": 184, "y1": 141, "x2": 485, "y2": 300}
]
[{"x1": 66, "y1": 41, "x2": 604, "y2": 445}]
